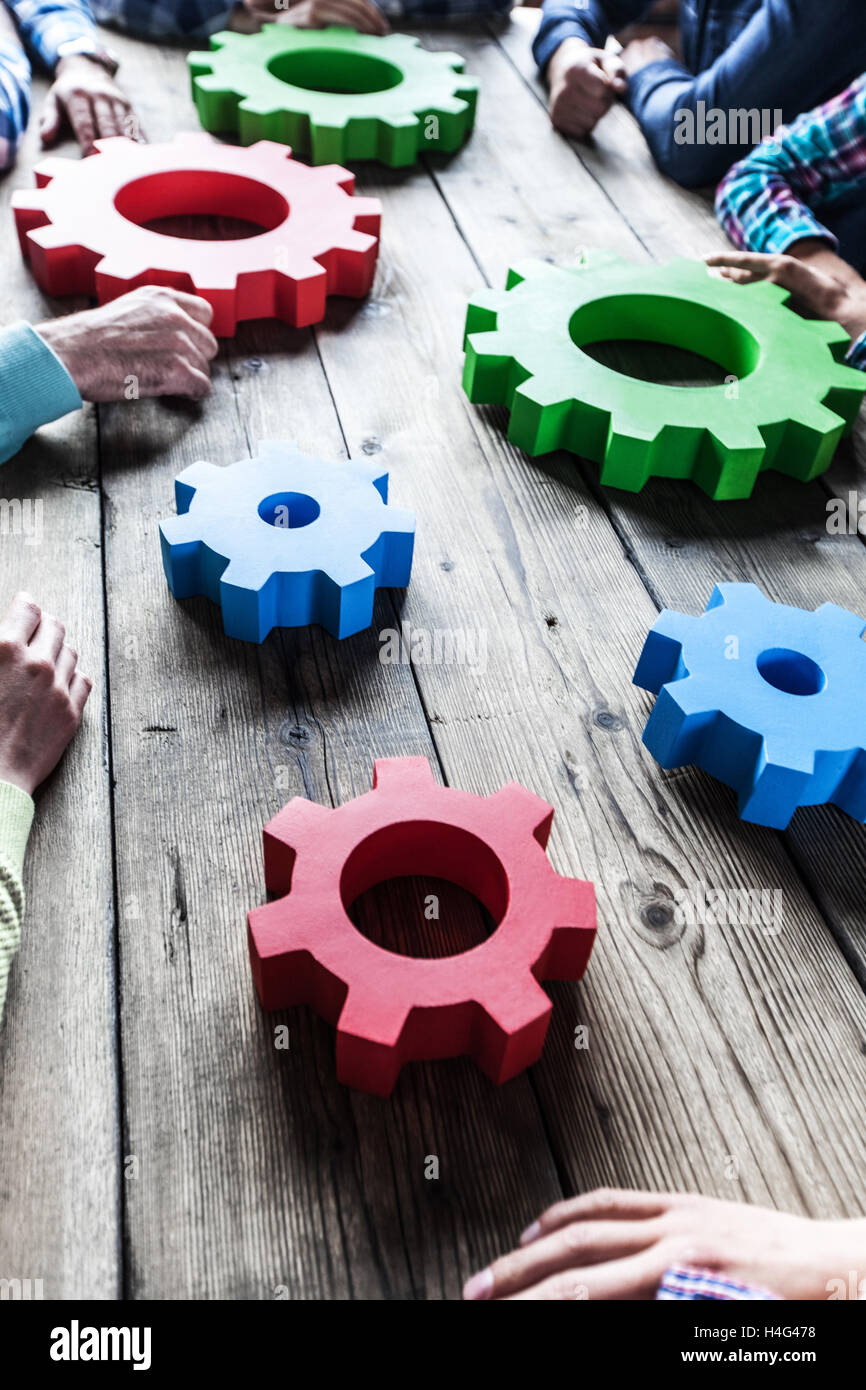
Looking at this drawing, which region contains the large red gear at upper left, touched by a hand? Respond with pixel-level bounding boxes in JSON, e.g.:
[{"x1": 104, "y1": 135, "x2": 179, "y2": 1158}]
[{"x1": 13, "y1": 132, "x2": 381, "y2": 338}]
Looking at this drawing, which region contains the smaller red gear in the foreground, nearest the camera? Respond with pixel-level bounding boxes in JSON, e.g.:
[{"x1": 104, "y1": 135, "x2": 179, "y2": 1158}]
[{"x1": 247, "y1": 758, "x2": 595, "y2": 1095}]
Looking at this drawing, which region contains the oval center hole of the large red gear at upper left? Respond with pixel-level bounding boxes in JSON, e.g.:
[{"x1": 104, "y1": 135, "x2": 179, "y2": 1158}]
[{"x1": 114, "y1": 170, "x2": 289, "y2": 242}]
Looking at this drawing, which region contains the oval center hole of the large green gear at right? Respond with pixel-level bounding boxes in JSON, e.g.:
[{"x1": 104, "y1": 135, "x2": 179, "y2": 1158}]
[{"x1": 569, "y1": 295, "x2": 760, "y2": 388}]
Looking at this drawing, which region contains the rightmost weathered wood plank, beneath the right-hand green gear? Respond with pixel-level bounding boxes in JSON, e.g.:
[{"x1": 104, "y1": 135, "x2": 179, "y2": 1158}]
[{"x1": 494, "y1": 11, "x2": 866, "y2": 988}]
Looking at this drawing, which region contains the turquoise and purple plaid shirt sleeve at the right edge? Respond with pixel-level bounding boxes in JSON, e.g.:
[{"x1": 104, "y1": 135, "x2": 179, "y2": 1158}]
[{"x1": 716, "y1": 76, "x2": 866, "y2": 254}]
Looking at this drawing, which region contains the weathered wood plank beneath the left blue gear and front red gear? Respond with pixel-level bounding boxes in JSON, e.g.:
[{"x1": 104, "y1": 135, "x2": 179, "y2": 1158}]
[{"x1": 101, "y1": 27, "x2": 562, "y2": 1298}]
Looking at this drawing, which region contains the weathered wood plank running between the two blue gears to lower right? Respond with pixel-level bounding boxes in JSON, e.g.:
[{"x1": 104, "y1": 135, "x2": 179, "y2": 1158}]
[{"x1": 304, "y1": 21, "x2": 865, "y2": 1213}]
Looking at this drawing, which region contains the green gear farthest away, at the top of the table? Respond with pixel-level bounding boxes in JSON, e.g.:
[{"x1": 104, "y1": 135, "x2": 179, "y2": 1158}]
[{"x1": 189, "y1": 24, "x2": 478, "y2": 168}]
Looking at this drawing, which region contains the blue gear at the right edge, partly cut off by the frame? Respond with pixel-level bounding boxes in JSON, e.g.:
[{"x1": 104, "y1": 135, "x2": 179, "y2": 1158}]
[{"x1": 634, "y1": 584, "x2": 866, "y2": 830}]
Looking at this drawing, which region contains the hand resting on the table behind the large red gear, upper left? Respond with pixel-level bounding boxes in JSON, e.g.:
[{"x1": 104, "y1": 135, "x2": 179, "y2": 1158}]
[{"x1": 39, "y1": 53, "x2": 140, "y2": 154}]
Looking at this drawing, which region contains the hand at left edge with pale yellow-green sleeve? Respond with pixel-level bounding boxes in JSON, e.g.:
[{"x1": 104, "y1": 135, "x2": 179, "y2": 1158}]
[{"x1": 0, "y1": 594, "x2": 93, "y2": 796}]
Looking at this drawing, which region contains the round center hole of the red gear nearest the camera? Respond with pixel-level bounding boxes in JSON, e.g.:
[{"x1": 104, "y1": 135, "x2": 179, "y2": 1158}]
[{"x1": 341, "y1": 821, "x2": 509, "y2": 959}]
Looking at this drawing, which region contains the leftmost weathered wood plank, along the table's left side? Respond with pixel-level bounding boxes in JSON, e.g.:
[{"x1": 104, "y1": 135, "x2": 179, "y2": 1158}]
[{"x1": 0, "y1": 92, "x2": 120, "y2": 1298}]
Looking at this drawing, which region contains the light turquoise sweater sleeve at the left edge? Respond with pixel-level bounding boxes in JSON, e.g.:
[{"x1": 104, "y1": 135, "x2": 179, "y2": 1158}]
[{"x1": 0, "y1": 324, "x2": 81, "y2": 463}]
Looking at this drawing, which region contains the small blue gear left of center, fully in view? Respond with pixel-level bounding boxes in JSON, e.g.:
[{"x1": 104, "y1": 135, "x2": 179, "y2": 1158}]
[{"x1": 160, "y1": 439, "x2": 414, "y2": 642}]
